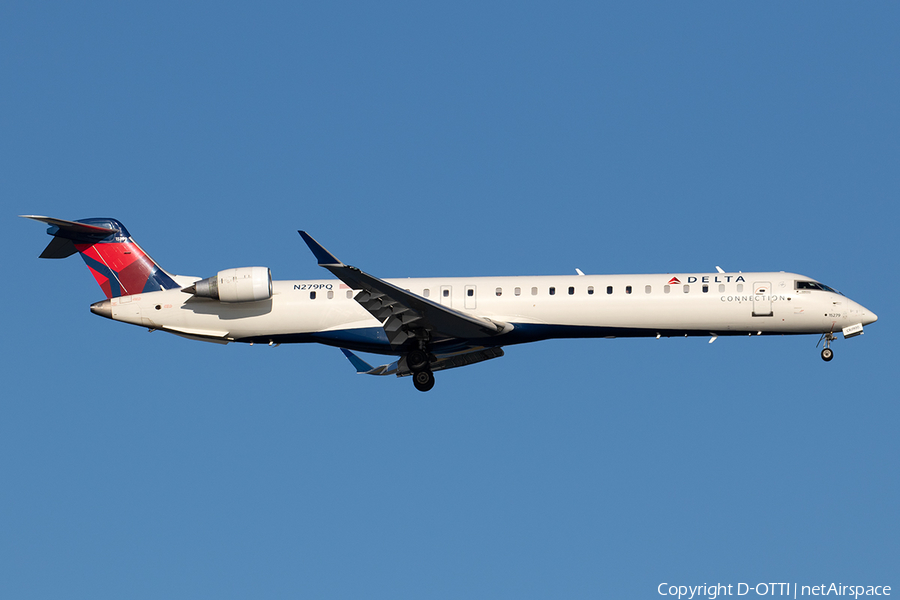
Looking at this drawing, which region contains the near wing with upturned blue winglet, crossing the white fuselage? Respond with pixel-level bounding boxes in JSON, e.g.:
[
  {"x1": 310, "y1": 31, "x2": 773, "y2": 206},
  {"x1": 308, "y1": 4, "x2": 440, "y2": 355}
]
[{"x1": 298, "y1": 231, "x2": 512, "y2": 347}]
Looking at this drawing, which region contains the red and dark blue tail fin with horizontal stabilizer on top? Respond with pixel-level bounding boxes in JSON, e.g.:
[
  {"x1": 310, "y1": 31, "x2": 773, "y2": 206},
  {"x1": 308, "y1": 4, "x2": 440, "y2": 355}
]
[{"x1": 22, "y1": 215, "x2": 181, "y2": 298}]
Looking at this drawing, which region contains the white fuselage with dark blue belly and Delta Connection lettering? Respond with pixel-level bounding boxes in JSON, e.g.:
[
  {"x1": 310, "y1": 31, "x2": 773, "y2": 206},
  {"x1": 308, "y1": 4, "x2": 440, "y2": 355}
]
[{"x1": 104, "y1": 272, "x2": 876, "y2": 354}]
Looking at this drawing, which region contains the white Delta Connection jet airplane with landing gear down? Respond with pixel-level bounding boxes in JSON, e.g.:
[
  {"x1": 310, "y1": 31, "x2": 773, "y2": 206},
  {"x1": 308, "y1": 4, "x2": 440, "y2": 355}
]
[{"x1": 21, "y1": 215, "x2": 878, "y2": 392}]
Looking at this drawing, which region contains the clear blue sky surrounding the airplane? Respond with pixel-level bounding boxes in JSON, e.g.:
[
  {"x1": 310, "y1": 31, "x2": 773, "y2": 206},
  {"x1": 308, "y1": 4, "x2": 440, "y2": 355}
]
[{"x1": 0, "y1": 2, "x2": 900, "y2": 599}]
